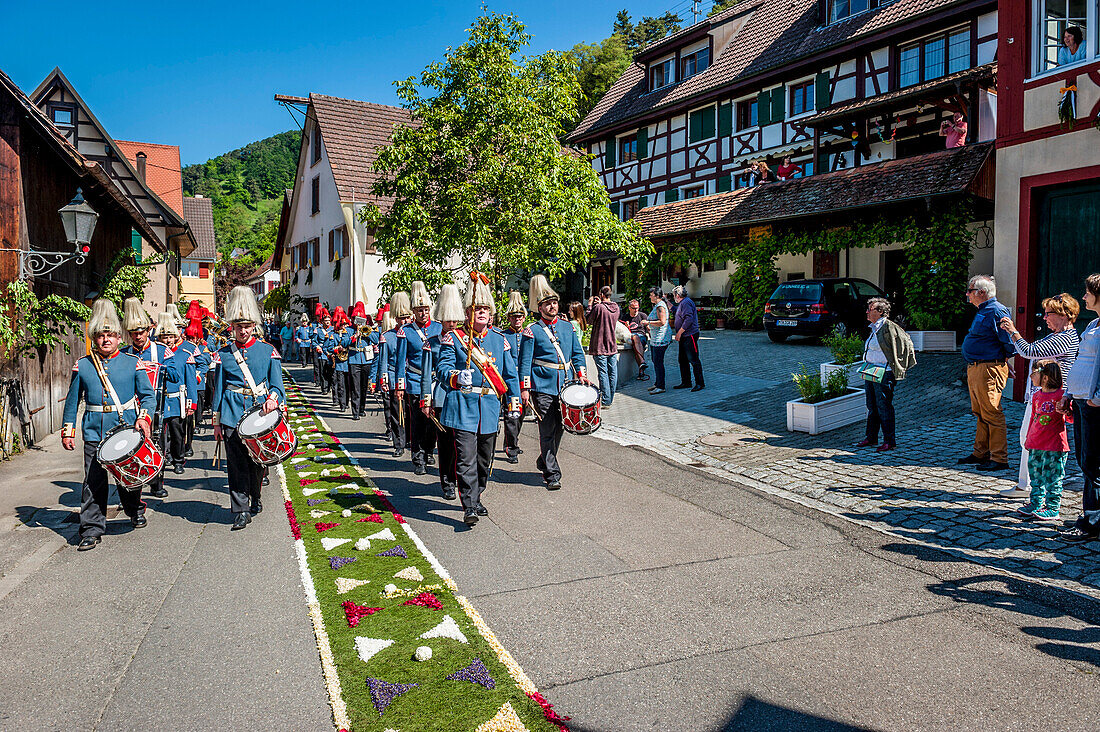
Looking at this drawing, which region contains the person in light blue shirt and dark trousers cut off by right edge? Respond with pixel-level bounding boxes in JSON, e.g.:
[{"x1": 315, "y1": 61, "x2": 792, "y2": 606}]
[{"x1": 1058, "y1": 274, "x2": 1100, "y2": 543}]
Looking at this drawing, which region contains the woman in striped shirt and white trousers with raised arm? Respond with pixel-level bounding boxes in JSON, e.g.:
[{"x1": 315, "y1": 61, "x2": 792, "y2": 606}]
[{"x1": 1001, "y1": 293, "x2": 1081, "y2": 498}]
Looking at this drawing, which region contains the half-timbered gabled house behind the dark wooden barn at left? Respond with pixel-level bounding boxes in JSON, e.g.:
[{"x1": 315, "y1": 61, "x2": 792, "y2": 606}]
[{"x1": 31, "y1": 68, "x2": 196, "y2": 312}]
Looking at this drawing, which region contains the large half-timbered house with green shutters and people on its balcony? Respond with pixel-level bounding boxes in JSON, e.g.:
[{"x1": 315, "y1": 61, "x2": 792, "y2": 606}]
[{"x1": 569, "y1": 0, "x2": 998, "y2": 295}]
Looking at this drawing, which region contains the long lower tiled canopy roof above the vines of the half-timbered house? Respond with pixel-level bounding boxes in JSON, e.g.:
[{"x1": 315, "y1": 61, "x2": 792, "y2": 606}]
[{"x1": 636, "y1": 142, "x2": 993, "y2": 239}]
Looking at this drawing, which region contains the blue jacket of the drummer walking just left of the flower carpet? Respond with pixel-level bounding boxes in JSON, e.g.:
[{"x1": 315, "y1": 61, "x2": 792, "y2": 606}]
[{"x1": 211, "y1": 338, "x2": 286, "y2": 427}]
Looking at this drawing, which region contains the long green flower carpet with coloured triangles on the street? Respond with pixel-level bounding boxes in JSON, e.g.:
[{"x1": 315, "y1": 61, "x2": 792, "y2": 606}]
[{"x1": 279, "y1": 376, "x2": 567, "y2": 732}]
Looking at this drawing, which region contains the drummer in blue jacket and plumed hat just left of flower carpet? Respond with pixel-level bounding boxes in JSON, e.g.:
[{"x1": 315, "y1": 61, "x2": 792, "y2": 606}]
[{"x1": 213, "y1": 285, "x2": 286, "y2": 531}]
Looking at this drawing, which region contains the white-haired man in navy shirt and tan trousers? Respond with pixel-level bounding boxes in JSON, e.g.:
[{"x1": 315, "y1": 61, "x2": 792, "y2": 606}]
[{"x1": 958, "y1": 274, "x2": 1014, "y2": 471}]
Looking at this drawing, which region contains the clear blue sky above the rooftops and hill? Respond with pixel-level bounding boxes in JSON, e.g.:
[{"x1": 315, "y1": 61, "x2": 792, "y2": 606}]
[{"x1": 0, "y1": 0, "x2": 695, "y2": 164}]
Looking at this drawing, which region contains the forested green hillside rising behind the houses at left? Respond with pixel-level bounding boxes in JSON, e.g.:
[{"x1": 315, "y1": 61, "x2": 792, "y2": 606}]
[{"x1": 184, "y1": 130, "x2": 301, "y2": 264}]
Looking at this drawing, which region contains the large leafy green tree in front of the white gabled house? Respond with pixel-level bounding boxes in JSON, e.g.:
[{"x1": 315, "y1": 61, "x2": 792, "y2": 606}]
[{"x1": 363, "y1": 13, "x2": 652, "y2": 290}]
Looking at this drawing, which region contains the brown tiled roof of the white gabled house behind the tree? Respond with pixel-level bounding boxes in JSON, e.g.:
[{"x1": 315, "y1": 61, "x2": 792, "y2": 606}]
[{"x1": 309, "y1": 94, "x2": 411, "y2": 205}]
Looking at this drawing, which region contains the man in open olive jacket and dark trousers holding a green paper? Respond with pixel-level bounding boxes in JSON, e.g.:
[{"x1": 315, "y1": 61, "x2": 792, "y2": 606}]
[{"x1": 856, "y1": 297, "x2": 916, "y2": 452}]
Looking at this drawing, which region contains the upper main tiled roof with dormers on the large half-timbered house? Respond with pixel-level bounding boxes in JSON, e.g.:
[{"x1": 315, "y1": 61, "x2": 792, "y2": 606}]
[{"x1": 567, "y1": 0, "x2": 967, "y2": 141}]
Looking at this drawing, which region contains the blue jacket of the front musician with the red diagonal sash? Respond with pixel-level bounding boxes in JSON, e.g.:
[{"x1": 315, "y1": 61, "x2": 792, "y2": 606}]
[{"x1": 429, "y1": 328, "x2": 520, "y2": 435}]
